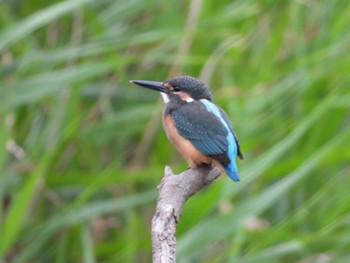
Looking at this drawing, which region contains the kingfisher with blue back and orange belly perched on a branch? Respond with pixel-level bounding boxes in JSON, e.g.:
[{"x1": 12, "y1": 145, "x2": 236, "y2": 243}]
[{"x1": 130, "y1": 76, "x2": 243, "y2": 182}]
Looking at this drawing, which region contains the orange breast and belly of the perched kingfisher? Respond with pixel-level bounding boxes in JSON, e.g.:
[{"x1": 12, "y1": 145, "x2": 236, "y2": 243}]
[{"x1": 163, "y1": 114, "x2": 213, "y2": 169}]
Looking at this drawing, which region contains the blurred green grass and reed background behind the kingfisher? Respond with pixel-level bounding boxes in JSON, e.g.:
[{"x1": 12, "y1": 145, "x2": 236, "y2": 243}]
[{"x1": 0, "y1": 0, "x2": 350, "y2": 263}]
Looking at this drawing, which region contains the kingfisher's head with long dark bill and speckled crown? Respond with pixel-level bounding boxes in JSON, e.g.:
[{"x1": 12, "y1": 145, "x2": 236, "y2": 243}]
[{"x1": 131, "y1": 76, "x2": 213, "y2": 102}]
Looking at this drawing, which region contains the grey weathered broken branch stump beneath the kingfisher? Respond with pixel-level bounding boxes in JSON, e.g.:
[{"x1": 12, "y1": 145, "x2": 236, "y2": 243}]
[{"x1": 152, "y1": 166, "x2": 221, "y2": 263}]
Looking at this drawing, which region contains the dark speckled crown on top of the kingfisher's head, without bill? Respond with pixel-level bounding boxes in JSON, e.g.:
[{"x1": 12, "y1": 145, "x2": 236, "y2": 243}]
[{"x1": 166, "y1": 76, "x2": 213, "y2": 101}]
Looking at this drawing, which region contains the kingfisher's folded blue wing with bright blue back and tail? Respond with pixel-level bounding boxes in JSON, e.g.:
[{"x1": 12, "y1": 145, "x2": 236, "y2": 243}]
[{"x1": 171, "y1": 100, "x2": 239, "y2": 181}]
